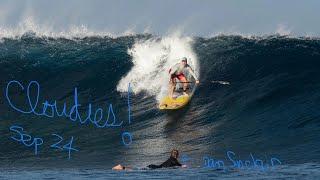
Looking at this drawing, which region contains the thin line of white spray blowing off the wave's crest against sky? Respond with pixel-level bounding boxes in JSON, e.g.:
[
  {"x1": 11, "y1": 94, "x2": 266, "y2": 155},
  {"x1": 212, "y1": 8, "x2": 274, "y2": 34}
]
[{"x1": 0, "y1": 16, "x2": 319, "y2": 41}]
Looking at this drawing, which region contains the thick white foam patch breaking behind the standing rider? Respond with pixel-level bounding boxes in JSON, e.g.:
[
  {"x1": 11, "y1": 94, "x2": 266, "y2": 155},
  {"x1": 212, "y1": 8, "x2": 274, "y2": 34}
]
[{"x1": 117, "y1": 34, "x2": 200, "y2": 100}]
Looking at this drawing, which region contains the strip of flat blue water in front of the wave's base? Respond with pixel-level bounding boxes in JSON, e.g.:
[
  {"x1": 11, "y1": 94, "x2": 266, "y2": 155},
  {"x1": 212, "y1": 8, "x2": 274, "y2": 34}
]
[{"x1": 0, "y1": 163, "x2": 320, "y2": 179}]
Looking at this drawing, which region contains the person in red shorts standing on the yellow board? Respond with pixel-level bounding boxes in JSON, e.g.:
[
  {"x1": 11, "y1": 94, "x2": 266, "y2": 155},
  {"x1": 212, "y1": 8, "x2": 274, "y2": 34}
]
[{"x1": 169, "y1": 57, "x2": 199, "y2": 98}]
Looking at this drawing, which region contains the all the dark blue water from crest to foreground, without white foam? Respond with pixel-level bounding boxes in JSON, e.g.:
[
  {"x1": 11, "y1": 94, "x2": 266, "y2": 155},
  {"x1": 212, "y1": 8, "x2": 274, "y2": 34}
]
[{"x1": 0, "y1": 34, "x2": 320, "y2": 179}]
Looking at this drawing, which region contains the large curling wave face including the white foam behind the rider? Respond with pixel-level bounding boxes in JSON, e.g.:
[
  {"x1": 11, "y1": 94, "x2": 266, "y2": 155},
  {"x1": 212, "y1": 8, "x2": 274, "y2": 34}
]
[{"x1": 0, "y1": 33, "x2": 320, "y2": 168}]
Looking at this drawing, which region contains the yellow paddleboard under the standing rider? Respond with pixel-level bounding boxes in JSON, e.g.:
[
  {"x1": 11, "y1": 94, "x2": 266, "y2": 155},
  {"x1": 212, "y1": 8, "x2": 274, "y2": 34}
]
[{"x1": 159, "y1": 81, "x2": 196, "y2": 110}]
